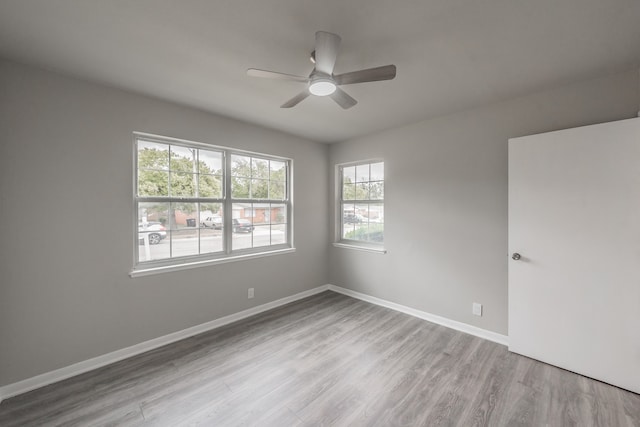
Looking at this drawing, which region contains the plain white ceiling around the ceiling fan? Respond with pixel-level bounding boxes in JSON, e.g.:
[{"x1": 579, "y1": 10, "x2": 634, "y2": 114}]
[{"x1": 0, "y1": 0, "x2": 640, "y2": 142}]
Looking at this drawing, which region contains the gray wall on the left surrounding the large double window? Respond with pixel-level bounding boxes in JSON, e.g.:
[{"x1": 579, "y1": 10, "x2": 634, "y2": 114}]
[{"x1": 0, "y1": 62, "x2": 329, "y2": 386}]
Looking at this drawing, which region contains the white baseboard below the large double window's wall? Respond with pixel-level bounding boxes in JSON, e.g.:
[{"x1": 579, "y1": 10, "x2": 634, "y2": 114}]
[{"x1": 0, "y1": 285, "x2": 329, "y2": 402}]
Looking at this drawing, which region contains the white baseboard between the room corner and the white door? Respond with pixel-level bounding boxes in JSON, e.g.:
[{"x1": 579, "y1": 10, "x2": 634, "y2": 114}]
[{"x1": 328, "y1": 285, "x2": 509, "y2": 346}]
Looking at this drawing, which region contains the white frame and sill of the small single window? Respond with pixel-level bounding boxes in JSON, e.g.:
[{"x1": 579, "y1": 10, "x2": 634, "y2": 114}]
[{"x1": 333, "y1": 158, "x2": 387, "y2": 254}]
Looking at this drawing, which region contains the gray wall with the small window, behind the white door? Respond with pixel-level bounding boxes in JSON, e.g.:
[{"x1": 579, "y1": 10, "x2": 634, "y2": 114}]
[{"x1": 329, "y1": 70, "x2": 640, "y2": 334}]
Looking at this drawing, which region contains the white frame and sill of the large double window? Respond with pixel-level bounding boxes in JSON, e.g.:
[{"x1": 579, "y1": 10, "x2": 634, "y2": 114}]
[{"x1": 129, "y1": 132, "x2": 295, "y2": 277}]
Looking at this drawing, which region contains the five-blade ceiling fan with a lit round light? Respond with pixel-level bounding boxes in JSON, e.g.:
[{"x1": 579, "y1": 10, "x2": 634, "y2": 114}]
[{"x1": 247, "y1": 31, "x2": 396, "y2": 109}]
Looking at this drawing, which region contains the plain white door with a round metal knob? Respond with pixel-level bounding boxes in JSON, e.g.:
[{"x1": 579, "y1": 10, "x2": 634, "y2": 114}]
[{"x1": 509, "y1": 118, "x2": 640, "y2": 393}]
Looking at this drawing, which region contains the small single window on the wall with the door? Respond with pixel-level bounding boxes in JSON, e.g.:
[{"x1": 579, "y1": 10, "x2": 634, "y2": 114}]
[{"x1": 338, "y1": 161, "x2": 384, "y2": 248}]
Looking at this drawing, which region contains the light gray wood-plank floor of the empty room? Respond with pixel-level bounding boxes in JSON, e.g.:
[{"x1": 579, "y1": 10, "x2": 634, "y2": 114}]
[{"x1": 0, "y1": 292, "x2": 640, "y2": 427}]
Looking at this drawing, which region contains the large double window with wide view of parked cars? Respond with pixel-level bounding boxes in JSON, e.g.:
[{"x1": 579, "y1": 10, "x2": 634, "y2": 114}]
[{"x1": 135, "y1": 134, "x2": 292, "y2": 268}]
